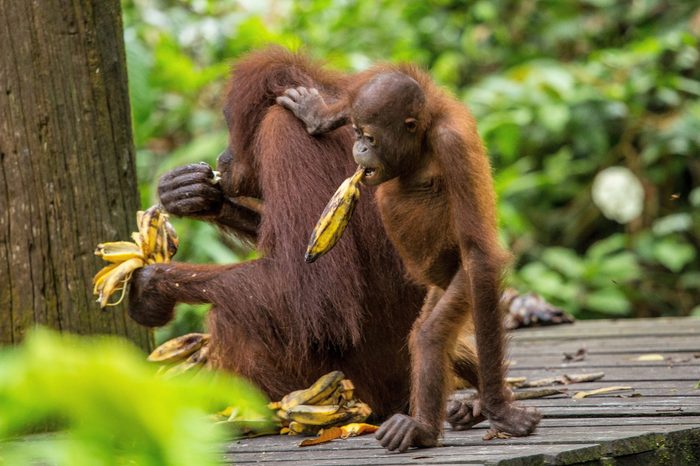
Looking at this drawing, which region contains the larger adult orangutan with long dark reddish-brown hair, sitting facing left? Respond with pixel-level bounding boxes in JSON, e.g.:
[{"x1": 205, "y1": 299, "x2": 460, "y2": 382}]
[{"x1": 129, "y1": 49, "x2": 424, "y2": 418}]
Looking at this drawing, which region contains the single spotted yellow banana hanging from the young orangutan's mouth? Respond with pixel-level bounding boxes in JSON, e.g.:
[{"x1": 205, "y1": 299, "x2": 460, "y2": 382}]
[{"x1": 304, "y1": 167, "x2": 364, "y2": 263}]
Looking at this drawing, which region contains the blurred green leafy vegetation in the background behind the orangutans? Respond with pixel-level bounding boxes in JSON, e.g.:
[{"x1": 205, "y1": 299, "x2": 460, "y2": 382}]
[{"x1": 124, "y1": 0, "x2": 700, "y2": 334}]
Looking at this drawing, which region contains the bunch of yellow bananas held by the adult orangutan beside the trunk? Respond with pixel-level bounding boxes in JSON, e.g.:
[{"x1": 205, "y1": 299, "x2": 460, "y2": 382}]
[{"x1": 92, "y1": 205, "x2": 178, "y2": 308}]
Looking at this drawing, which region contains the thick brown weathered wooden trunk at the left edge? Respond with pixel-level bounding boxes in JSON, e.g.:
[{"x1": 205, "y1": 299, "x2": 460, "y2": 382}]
[{"x1": 0, "y1": 0, "x2": 151, "y2": 348}]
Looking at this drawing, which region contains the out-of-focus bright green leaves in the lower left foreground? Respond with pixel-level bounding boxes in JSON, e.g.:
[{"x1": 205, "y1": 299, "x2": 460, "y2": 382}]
[{"x1": 0, "y1": 329, "x2": 267, "y2": 466}]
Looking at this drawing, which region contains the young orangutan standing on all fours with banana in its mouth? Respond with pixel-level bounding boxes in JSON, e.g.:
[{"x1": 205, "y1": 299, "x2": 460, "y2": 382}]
[{"x1": 277, "y1": 66, "x2": 541, "y2": 452}]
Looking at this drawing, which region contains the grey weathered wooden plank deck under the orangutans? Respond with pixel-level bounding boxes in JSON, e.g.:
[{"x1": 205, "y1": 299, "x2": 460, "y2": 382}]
[{"x1": 225, "y1": 319, "x2": 700, "y2": 465}]
